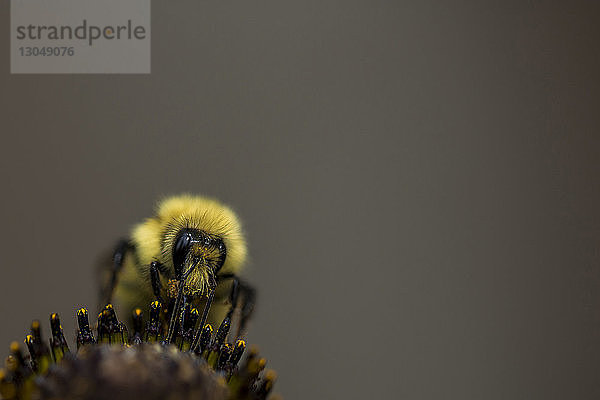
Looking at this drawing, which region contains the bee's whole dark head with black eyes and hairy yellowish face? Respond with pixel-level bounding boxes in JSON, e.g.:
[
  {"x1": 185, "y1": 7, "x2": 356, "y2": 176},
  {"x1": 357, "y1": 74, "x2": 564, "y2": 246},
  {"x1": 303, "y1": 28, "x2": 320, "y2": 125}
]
[{"x1": 172, "y1": 228, "x2": 227, "y2": 296}]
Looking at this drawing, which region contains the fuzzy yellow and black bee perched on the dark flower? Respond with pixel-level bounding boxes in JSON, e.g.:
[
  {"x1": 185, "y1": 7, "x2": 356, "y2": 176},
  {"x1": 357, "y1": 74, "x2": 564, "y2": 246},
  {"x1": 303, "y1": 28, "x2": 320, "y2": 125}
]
[{"x1": 101, "y1": 195, "x2": 255, "y2": 342}]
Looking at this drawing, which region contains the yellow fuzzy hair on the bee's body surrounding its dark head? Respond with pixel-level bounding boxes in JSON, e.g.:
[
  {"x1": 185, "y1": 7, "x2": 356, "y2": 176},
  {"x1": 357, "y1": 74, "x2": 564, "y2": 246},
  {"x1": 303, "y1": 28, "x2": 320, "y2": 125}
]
[{"x1": 115, "y1": 194, "x2": 246, "y2": 314}]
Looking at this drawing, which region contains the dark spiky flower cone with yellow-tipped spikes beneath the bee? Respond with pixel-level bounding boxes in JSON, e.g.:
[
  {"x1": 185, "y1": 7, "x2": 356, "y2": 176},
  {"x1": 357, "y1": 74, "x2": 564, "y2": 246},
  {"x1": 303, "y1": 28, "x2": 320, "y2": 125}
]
[{"x1": 0, "y1": 302, "x2": 274, "y2": 400}]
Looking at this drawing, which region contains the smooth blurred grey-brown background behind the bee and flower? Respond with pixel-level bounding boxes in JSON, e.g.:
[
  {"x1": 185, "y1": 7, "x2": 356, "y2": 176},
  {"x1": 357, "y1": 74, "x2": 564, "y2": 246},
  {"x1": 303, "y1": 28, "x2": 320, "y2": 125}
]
[{"x1": 0, "y1": 0, "x2": 600, "y2": 400}]
